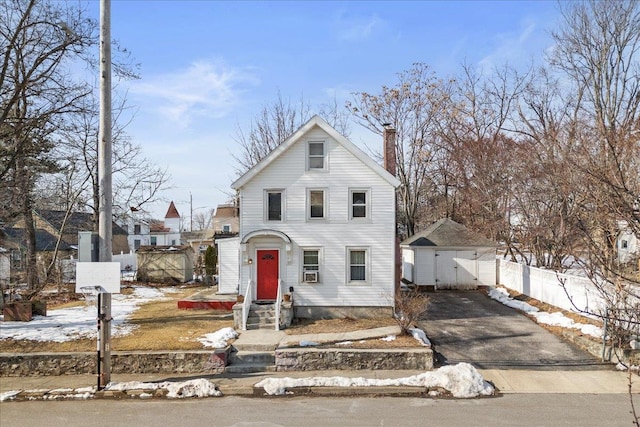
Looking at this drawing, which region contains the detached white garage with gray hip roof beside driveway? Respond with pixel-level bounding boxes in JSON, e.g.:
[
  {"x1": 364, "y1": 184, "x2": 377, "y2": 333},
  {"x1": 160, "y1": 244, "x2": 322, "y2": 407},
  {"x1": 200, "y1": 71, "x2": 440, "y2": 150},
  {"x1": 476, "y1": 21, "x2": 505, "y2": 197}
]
[{"x1": 400, "y1": 218, "x2": 496, "y2": 289}]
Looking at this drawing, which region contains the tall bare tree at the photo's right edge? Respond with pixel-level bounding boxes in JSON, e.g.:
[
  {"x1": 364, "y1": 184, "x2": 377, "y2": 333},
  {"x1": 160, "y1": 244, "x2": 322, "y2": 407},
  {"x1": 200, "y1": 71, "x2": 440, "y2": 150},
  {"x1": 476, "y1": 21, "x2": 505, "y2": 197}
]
[{"x1": 551, "y1": 0, "x2": 640, "y2": 414}]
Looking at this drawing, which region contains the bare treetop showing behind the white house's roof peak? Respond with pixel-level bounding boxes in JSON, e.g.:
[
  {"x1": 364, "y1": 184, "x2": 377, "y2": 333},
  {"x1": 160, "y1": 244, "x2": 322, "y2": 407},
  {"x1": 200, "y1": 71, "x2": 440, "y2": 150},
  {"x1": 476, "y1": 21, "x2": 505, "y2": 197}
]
[{"x1": 233, "y1": 91, "x2": 349, "y2": 175}]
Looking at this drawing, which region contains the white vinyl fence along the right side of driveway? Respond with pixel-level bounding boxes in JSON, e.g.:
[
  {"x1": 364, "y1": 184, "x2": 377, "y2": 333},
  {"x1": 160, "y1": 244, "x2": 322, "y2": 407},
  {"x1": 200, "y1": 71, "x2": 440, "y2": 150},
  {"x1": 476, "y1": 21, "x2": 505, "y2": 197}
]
[{"x1": 497, "y1": 259, "x2": 606, "y2": 313}]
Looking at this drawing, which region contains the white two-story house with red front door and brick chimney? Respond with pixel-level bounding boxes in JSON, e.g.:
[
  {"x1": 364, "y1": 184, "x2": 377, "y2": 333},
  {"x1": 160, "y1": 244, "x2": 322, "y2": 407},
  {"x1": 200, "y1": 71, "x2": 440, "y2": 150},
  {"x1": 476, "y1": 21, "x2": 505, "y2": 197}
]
[{"x1": 230, "y1": 116, "x2": 399, "y2": 317}]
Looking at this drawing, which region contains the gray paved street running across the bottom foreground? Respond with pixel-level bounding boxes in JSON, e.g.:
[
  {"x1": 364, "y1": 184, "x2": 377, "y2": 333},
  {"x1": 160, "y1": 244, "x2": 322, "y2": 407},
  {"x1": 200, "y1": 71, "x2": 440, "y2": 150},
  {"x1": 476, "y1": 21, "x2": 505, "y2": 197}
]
[{"x1": 0, "y1": 394, "x2": 632, "y2": 427}]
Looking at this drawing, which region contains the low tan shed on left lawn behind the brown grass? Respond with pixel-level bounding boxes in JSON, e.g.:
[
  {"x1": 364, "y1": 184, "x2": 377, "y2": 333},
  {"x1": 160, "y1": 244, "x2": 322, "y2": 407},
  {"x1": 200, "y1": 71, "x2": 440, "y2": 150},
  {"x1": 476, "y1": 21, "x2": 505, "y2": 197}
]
[{"x1": 136, "y1": 245, "x2": 194, "y2": 282}]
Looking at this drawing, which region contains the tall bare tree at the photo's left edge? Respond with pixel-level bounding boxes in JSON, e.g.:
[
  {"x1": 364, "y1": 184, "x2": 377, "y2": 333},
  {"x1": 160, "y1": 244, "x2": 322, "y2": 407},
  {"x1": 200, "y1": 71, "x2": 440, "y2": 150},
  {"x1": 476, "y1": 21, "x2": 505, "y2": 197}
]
[{"x1": 0, "y1": 0, "x2": 95, "y2": 290}]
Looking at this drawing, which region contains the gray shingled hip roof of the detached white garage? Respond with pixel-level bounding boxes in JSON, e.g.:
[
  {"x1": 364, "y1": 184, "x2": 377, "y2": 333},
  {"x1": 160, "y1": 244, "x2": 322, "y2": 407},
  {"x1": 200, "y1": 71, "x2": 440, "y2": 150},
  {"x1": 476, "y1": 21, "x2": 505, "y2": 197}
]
[{"x1": 401, "y1": 218, "x2": 496, "y2": 247}]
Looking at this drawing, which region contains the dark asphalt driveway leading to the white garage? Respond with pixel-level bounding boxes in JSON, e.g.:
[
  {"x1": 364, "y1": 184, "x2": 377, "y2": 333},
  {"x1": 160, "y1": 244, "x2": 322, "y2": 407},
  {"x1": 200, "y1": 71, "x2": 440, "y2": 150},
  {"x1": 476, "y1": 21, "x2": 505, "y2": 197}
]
[{"x1": 419, "y1": 291, "x2": 611, "y2": 370}]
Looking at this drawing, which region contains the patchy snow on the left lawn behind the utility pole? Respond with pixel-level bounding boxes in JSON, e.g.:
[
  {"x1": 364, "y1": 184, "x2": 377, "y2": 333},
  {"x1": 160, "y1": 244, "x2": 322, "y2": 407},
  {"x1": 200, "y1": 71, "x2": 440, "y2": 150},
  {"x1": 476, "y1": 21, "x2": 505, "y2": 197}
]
[{"x1": 0, "y1": 287, "x2": 170, "y2": 342}]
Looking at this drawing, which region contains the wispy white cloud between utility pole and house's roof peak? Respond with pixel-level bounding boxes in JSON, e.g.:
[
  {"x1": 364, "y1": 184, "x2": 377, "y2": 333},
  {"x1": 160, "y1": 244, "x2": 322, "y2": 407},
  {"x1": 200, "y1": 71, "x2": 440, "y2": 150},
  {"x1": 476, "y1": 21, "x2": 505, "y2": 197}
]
[{"x1": 131, "y1": 61, "x2": 258, "y2": 127}]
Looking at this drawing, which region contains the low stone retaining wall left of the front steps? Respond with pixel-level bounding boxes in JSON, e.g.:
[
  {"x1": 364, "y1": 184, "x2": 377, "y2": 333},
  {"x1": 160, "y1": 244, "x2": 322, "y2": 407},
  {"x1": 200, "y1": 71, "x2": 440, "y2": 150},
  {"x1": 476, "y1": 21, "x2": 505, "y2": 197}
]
[{"x1": 0, "y1": 348, "x2": 229, "y2": 377}]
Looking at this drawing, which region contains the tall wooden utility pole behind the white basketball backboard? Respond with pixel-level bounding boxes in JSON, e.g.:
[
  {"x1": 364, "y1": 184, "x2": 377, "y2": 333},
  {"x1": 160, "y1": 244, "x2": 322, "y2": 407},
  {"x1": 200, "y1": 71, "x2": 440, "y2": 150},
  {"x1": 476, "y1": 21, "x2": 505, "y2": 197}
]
[{"x1": 98, "y1": 0, "x2": 113, "y2": 390}]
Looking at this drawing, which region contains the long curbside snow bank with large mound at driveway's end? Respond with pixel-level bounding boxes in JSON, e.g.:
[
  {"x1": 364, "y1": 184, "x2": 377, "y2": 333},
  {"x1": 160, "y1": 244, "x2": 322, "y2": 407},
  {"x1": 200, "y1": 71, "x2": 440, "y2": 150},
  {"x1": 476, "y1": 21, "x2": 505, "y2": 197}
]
[{"x1": 255, "y1": 363, "x2": 495, "y2": 398}]
